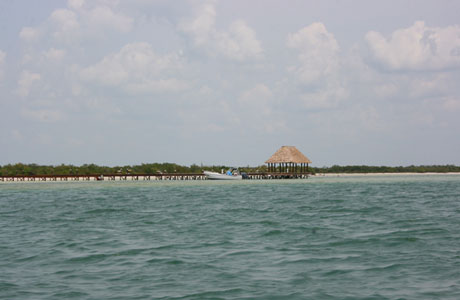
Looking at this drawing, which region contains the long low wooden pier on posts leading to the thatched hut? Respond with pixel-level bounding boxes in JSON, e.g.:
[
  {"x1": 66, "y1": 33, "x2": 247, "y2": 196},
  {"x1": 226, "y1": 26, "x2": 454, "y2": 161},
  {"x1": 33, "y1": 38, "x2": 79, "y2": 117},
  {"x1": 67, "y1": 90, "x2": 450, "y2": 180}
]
[{"x1": 0, "y1": 172, "x2": 310, "y2": 182}]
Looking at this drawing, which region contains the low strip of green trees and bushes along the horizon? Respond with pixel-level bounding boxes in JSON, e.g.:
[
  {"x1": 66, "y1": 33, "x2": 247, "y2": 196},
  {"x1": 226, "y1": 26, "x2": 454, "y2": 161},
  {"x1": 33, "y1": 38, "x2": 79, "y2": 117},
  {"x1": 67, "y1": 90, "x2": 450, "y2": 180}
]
[{"x1": 0, "y1": 163, "x2": 460, "y2": 176}]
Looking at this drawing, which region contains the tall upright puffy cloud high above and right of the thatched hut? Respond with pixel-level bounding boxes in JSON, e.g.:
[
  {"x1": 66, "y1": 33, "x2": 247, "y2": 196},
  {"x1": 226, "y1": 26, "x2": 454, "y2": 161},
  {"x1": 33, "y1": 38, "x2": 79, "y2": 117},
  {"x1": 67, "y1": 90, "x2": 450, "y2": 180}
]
[{"x1": 287, "y1": 23, "x2": 339, "y2": 84}]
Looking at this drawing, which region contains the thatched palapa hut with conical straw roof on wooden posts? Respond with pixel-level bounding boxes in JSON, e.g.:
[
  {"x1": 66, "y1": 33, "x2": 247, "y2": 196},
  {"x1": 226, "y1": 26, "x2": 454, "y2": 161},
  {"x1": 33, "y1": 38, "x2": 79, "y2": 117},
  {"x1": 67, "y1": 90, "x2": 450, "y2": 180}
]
[{"x1": 265, "y1": 146, "x2": 311, "y2": 173}]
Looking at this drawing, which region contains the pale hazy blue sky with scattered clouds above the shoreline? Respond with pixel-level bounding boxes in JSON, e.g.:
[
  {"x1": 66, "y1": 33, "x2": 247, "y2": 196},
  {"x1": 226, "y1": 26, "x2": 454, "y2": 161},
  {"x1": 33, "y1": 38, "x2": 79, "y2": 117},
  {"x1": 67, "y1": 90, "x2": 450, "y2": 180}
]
[{"x1": 0, "y1": 0, "x2": 460, "y2": 167}]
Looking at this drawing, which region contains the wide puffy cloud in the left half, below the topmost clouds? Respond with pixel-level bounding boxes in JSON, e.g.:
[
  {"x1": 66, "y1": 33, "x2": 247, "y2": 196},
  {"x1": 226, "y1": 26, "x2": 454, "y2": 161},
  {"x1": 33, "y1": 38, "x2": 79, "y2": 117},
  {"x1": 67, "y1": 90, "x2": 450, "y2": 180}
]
[{"x1": 80, "y1": 43, "x2": 187, "y2": 93}]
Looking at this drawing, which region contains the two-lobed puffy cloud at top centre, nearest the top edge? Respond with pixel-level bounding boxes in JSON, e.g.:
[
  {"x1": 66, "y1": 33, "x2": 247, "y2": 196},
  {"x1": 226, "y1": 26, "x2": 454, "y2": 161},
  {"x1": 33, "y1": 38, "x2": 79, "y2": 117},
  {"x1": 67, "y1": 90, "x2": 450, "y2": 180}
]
[{"x1": 179, "y1": 3, "x2": 263, "y2": 61}]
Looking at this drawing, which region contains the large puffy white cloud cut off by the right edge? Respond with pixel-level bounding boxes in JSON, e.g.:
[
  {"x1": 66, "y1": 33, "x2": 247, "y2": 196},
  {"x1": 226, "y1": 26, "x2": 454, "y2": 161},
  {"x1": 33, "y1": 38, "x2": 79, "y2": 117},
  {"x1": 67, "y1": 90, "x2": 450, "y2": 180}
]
[{"x1": 366, "y1": 21, "x2": 460, "y2": 71}]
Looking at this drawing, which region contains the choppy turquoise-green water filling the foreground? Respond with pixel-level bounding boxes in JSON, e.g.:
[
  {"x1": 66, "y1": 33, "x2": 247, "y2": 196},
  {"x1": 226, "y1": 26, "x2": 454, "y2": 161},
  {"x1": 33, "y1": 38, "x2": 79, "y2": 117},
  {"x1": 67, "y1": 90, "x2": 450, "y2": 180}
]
[{"x1": 0, "y1": 175, "x2": 460, "y2": 299}]
